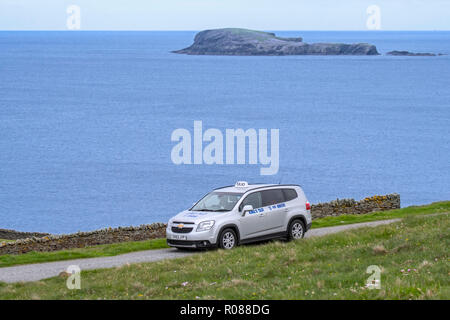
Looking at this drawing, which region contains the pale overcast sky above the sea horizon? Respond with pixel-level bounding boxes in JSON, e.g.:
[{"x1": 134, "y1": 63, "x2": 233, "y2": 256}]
[{"x1": 0, "y1": 0, "x2": 450, "y2": 30}]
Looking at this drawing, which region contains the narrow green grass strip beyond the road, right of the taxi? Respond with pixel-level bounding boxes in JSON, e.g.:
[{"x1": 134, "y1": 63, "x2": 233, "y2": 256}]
[{"x1": 312, "y1": 201, "x2": 450, "y2": 228}]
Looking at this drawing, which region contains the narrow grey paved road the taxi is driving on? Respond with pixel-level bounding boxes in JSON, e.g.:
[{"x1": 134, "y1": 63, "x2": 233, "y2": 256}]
[{"x1": 0, "y1": 219, "x2": 400, "y2": 282}]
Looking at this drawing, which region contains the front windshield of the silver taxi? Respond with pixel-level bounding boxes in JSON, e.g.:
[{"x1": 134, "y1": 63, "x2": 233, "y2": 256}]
[{"x1": 191, "y1": 192, "x2": 242, "y2": 212}]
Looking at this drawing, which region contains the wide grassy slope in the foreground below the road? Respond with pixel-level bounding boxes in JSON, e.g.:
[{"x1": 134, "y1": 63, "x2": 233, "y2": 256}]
[{"x1": 0, "y1": 214, "x2": 450, "y2": 299}]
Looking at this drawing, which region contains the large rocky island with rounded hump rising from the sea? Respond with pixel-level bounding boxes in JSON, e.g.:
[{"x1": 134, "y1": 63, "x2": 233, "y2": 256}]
[{"x1": 173, "y1": 28, "x2": 379, "y2": 56}]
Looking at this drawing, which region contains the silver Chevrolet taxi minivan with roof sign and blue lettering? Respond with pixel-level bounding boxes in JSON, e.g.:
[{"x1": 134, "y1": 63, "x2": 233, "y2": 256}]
[{"x1": 166, "y1": 181, "x2": 311, "y2": 249}]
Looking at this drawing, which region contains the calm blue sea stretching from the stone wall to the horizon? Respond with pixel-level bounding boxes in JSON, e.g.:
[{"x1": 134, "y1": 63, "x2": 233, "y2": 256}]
[{"x1": 0, "y1": 32, "x2": 450, "y2": 233}]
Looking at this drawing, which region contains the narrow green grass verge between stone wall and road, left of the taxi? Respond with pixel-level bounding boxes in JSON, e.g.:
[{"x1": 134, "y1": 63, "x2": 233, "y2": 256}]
[{"x1": 0, "y1": 239, "x2": 168, "y2": 267}]
